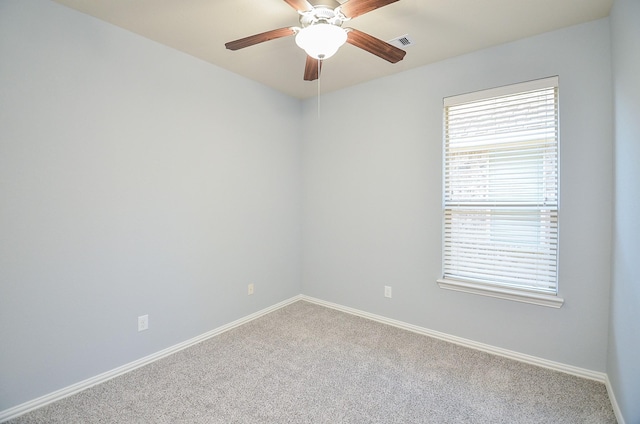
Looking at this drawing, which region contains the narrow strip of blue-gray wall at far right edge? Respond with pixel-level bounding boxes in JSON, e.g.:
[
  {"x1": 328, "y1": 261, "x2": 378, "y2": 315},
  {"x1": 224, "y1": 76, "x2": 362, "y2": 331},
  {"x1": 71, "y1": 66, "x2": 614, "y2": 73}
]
[{"x1": 607, "y1": 0, "x2": 640, "y2": 423}]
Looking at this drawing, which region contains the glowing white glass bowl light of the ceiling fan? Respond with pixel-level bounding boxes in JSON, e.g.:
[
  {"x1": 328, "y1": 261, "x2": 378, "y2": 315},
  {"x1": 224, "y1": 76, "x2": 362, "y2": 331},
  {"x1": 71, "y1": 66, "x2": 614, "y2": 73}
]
[{"x1": 296, "y1": 23, "x2": 347, "y2": 60}]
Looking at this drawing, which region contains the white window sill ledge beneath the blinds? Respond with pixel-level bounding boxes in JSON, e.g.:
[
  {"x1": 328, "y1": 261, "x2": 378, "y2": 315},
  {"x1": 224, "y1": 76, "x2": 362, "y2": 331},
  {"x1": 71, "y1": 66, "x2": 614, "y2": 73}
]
[{"x1": 438, "y1": 279, "x2": 564, "y2": 308}]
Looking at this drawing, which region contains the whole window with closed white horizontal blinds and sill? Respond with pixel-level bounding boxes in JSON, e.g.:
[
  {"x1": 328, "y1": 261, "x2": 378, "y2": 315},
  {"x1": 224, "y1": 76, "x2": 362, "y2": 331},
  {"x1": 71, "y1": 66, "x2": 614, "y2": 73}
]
[{"x1": 438, "y1": 77, "x2": 563, "y2": 307}]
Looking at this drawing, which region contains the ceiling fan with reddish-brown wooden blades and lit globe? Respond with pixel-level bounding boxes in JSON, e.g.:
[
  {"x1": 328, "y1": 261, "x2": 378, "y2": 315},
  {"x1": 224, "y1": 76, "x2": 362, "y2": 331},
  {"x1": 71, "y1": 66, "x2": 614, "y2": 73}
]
[{"x1": 225, "y1": 0, "x2": 406, "y2": 81}]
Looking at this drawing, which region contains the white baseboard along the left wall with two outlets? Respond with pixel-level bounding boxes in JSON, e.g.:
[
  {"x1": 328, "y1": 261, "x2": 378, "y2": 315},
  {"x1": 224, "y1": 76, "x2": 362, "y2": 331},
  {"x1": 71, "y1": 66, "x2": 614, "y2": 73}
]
[{"x1": 0, "y1": 295, "x2": 301, "y2": 423}]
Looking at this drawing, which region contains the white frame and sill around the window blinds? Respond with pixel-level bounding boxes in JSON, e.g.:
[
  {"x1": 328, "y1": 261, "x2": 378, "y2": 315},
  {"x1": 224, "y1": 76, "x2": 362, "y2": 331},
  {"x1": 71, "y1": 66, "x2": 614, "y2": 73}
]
[{"x1": 437, "y1": 76, "x2": 564, "y2": 308}]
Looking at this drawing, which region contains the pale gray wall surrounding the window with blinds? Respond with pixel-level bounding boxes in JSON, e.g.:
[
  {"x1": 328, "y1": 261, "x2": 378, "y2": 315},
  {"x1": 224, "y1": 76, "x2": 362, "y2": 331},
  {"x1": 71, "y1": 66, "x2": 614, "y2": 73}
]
[{"x1": 302, "y1": 19, "x2": 613, "y2": 372}]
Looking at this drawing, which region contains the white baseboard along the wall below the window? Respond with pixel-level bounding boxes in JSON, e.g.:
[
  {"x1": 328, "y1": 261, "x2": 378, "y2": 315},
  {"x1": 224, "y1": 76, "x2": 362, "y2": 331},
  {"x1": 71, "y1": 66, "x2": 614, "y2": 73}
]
[{"x1": 301, "y1": 295, "x2": 607, "y2": 383}]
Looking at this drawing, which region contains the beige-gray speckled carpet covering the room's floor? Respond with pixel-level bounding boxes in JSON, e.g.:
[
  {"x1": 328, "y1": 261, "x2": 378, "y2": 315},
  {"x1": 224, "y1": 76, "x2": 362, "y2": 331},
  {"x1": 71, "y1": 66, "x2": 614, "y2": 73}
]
[{"x1": 10, "y1": 301, "x2": 616, "y2": 424}]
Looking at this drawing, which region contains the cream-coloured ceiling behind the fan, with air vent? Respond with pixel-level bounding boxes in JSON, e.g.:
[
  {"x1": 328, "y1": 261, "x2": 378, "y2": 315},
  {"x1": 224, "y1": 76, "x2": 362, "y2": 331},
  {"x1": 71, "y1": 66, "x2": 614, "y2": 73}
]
[{"x1": 55, "y1": 0, "x2": 613, "y2": 99}]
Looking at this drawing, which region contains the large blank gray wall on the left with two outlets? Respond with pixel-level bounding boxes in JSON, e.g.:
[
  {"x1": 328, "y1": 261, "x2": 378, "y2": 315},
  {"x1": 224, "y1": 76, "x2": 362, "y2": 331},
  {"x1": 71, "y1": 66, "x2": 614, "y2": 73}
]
[{"x1": 0, "y1": 0, "x2": 301, "y2": 410}]
